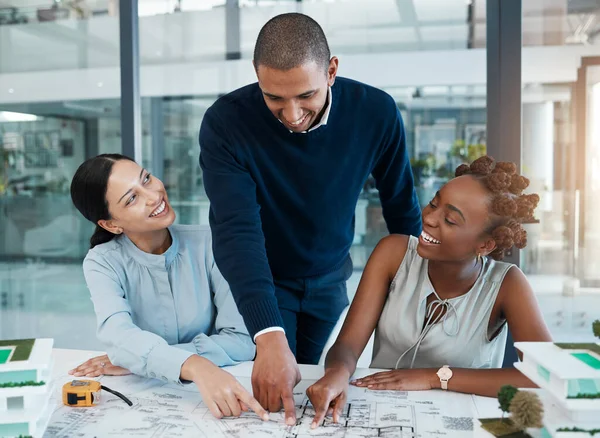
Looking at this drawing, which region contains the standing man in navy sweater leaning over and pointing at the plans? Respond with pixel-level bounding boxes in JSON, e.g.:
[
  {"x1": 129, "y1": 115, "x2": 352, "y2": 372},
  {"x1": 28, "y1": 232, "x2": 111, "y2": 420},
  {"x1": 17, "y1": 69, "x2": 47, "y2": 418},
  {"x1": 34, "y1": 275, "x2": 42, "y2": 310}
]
[{"x1": 200, "y1": 14, "x2": 421, "y2": 424}]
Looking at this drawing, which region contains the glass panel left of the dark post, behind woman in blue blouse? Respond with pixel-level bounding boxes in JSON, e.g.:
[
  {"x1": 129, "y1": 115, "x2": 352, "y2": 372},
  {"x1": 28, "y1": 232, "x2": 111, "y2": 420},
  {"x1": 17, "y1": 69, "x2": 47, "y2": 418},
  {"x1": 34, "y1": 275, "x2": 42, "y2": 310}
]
[{"x1": 0, "y1": 5, "x2": 121, "y2": 349}]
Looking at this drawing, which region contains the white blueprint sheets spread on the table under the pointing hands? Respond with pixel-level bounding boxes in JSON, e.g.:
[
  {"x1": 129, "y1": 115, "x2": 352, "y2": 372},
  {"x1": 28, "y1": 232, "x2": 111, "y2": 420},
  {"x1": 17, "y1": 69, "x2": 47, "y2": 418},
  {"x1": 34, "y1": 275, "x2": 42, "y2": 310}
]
[{"x1": 44, "y1": 370, "x2": 474, "y2": 438}]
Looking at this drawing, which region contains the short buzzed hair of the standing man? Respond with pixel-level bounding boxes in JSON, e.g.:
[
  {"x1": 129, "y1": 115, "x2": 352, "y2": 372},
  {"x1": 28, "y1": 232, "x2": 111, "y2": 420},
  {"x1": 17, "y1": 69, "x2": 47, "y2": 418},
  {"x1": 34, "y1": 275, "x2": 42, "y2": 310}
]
[{"x1": 254, "y1": 13, "x2": 331, "y2": 71}]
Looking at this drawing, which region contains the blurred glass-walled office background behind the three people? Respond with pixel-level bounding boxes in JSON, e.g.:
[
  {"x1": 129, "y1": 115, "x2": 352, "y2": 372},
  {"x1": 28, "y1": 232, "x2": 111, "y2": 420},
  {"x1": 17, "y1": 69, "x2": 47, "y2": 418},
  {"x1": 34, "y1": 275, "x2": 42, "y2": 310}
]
[{"x1": 0, "y1": 0, "x2": 600, "y2": 349}]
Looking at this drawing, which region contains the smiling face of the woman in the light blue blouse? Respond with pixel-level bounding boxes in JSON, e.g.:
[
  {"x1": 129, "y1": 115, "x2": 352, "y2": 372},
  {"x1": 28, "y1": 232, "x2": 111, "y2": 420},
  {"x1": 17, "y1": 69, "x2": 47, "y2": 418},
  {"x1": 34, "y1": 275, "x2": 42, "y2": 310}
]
[{"x1": 98, "y1": 160, "x2": 175, "y2": 234}]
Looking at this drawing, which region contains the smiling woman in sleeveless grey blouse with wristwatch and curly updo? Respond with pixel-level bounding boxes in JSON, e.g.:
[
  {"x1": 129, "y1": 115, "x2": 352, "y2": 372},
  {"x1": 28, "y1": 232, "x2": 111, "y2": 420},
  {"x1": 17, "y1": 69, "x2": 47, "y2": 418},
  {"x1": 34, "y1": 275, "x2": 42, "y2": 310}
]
[{"x1": 308, "y1": 156, "x2": 551, "y2": 425}]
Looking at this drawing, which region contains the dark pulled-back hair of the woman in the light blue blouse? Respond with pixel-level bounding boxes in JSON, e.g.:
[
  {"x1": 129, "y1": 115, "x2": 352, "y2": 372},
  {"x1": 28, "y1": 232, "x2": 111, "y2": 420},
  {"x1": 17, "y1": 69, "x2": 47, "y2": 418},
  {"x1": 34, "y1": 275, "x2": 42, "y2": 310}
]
[{"x1": 71, "y1": 154, "x2": 133, "y2": 248}]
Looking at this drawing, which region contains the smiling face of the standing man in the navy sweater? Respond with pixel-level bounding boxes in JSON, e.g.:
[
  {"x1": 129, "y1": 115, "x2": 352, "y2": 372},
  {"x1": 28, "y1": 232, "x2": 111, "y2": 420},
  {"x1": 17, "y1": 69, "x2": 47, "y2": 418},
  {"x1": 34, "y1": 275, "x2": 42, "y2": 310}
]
[{"x1": 256, "y1": 57, "x2": 338, "y2": 132}]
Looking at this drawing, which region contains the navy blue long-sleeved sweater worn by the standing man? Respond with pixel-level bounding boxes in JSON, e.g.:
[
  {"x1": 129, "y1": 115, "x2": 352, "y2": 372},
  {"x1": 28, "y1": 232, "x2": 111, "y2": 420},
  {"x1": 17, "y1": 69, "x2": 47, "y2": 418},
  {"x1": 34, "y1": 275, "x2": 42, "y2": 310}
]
[{"x1": 200, "y1": 78, "x2": 421, "y2": 336}]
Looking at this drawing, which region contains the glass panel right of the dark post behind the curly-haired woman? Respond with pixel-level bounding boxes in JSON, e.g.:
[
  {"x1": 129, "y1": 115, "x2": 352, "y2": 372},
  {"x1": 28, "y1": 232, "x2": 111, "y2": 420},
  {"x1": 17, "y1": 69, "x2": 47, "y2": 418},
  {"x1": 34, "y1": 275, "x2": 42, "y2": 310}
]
[{"x1": 522, "y1": 0, "x2": 600, "y2": 342}]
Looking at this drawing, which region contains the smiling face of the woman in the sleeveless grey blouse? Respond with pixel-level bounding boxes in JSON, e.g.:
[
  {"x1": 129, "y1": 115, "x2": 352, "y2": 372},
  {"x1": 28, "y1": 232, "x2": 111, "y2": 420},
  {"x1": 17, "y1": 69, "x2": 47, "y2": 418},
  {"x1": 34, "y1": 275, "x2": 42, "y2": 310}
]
[{"x1": 417, "y1": 175, "x2": 495, "y2": 262}]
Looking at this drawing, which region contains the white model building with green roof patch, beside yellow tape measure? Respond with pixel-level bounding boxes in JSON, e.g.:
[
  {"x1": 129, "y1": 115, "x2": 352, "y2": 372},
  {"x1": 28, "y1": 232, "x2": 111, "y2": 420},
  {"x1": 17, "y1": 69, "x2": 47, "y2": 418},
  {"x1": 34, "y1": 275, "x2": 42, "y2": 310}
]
[{"x1": 0, "y1": 339, "x2": 54, "y2": 437}]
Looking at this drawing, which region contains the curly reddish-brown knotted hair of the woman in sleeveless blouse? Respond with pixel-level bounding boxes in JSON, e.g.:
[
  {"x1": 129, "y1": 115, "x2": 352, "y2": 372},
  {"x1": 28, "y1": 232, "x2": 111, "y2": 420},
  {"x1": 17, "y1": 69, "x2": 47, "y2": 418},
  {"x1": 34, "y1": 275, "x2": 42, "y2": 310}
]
[{"x1": 455, "y1": 155, "x2": 540, "y2": 260}]
